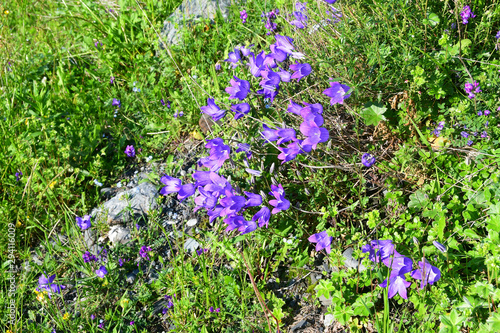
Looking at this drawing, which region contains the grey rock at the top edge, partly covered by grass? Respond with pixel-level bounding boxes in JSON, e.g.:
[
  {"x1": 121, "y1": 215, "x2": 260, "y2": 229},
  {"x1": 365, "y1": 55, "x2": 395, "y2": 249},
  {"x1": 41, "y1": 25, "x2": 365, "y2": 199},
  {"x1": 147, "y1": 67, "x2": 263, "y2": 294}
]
[{"x1": 160, "y1": 0, "x2": 231, "y2": 48}]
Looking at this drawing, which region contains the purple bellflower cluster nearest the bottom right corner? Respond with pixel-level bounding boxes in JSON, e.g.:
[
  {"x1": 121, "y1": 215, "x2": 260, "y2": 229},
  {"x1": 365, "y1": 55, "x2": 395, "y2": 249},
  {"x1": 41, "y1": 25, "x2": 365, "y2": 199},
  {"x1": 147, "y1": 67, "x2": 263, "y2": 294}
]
[{"x1": 361, "y1": 240, "x2": 441, "y2": 299}]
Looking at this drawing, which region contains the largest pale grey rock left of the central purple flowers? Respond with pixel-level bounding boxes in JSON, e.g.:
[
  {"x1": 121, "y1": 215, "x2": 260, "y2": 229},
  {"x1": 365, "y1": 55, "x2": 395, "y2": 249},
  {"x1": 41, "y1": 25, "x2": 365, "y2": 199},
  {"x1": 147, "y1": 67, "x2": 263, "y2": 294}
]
[{"x1": 91, "y1": 182, "x2": 158, "y2": 225}]
